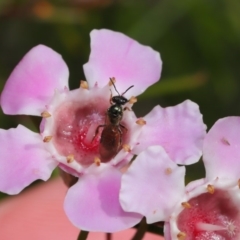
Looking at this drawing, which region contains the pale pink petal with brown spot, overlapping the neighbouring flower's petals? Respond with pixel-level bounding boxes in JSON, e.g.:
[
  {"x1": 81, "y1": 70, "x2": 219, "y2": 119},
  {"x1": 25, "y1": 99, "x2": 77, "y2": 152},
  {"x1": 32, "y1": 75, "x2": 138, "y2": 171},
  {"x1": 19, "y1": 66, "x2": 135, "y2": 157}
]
[{"x1": 120, "y1": 146, "x2": 185, "y2": 223}]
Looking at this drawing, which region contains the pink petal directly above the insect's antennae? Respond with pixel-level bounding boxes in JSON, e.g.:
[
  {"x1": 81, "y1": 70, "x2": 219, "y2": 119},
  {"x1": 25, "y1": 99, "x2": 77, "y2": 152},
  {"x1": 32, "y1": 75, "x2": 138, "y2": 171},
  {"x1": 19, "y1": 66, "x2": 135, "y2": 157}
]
[{"x1": 83, "y1": 29, "x2": 162, "y2": 97}]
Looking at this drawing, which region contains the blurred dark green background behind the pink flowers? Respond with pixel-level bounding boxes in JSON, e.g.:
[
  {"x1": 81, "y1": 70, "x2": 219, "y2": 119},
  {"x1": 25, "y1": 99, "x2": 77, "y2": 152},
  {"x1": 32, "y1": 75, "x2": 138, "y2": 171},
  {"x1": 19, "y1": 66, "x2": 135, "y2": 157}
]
[{"x1": 0, "y1": 0, "x2": 240, "y2": 198}]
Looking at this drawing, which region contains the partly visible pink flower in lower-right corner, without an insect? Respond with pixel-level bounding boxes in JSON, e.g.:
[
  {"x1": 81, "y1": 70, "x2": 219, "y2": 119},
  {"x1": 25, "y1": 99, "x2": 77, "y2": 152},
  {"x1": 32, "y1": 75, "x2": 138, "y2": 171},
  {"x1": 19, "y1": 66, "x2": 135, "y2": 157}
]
[{"x1": 120, "y1": 117, "x2": 240, "y2": 240}]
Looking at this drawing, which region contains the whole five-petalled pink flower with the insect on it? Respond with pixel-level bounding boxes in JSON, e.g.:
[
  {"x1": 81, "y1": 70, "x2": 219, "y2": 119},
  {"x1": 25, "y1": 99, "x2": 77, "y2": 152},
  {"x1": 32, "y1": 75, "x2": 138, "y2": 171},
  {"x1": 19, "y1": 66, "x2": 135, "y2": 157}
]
[{"x1": 0, "y1": 30, "x2": 205, "y2": 232}]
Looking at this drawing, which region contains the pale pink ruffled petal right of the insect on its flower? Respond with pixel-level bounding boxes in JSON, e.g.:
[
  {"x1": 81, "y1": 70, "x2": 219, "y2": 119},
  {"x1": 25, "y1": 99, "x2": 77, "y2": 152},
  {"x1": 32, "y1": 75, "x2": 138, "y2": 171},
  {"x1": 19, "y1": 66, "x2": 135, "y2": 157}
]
[{"x1": 133, "y1": 100, "x2": 206, "y2": 165}]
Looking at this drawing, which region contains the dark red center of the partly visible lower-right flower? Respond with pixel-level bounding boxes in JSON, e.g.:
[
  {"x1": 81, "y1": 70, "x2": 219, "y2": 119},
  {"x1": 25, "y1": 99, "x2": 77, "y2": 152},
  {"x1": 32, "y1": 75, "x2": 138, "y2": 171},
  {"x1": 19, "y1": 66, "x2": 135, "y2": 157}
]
[{"x1": 177, "y1": 190, "x2": 240, "y2": 240}]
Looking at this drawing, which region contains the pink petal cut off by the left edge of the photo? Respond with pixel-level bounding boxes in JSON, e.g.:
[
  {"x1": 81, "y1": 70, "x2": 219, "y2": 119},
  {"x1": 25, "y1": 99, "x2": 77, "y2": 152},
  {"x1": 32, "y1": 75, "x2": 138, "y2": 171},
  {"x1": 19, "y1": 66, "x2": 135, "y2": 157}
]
[{"x1": 0, "y1": 125, "x2": 57, "y2": 194}]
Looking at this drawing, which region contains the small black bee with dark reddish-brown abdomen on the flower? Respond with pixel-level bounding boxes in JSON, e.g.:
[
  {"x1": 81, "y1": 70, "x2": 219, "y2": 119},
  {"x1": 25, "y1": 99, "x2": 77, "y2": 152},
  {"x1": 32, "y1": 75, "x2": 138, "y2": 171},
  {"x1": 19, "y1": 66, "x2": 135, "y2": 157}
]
[{"x1": 95, "y1": 78, "x2": 133, "y2": 162}]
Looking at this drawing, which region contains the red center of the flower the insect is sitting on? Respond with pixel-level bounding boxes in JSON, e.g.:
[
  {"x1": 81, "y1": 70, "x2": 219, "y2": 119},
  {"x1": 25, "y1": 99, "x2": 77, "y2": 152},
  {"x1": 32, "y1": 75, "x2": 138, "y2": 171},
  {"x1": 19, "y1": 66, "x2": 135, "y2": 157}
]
[{"x1": 53, "y1": 98, "x2": 127, "y2": 166}]
